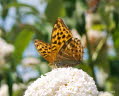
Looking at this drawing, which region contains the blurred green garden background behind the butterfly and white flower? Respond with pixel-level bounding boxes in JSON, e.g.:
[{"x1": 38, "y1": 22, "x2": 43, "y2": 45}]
[{"x1": 0, "y1": 0, "x2": 119, "y2": 96}]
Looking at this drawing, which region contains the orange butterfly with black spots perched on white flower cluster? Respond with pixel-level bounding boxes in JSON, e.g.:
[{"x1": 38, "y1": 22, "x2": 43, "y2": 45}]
[{"x1": 34, "y1": 18, "x2": 83, "y2": 67}]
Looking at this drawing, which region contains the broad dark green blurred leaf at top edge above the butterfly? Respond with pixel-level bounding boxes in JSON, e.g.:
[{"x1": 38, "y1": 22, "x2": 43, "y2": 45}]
[{"x1": 46, "y1": 0, "x2": 65, "y2": 22}]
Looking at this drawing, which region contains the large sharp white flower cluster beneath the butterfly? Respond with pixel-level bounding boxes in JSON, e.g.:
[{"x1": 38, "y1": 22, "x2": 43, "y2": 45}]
[{"x1": 24, "y1": 67, "x2": 98, "y2": 96}]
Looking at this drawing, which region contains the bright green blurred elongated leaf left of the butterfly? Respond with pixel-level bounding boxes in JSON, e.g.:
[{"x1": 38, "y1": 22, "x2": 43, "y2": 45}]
[{"x1": 14, "y1": 29, "x2": 33, "y2": 62}]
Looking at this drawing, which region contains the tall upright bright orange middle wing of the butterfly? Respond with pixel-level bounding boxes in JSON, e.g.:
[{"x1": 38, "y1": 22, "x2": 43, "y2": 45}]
[{"x1": 51, "y1": 18, "x2": 72, "y2": 59}]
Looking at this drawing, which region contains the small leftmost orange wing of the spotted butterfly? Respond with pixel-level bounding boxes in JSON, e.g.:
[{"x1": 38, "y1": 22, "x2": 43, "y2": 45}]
[{"x1": 34, "y1": 40, "x2": 52, "y2": 62}]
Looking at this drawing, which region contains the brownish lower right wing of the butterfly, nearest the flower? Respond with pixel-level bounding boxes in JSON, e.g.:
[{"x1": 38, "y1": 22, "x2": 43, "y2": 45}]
[{"x1": 55, "y1": 38, "x2": 83, "y2": 67}]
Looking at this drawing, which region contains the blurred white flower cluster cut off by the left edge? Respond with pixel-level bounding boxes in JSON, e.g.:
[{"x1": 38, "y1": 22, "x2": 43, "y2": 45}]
[{"x1": 0, "y1": 38, "x2": 14, "y2": 64}]
